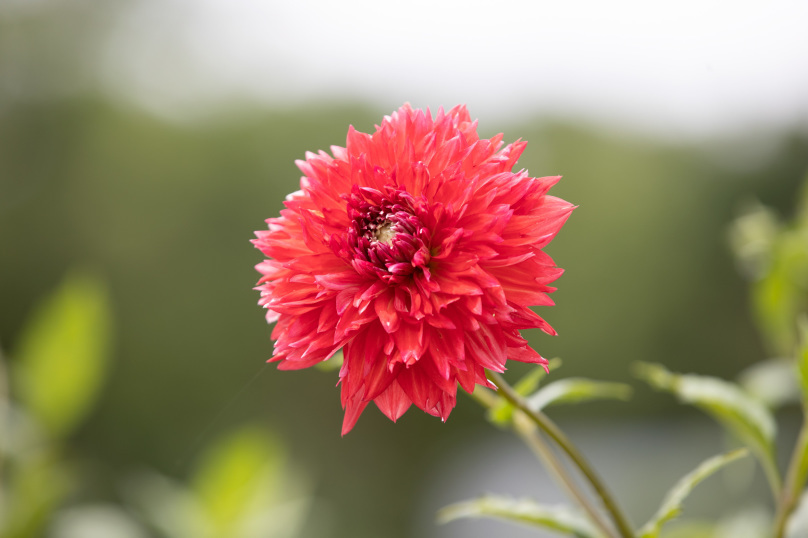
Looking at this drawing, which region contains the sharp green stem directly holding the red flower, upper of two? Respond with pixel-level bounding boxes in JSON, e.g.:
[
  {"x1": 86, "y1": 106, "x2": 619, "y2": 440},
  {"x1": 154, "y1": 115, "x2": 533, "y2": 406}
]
[{"x1": 488, "y1": 371, "x2": 634, "y2": 538}]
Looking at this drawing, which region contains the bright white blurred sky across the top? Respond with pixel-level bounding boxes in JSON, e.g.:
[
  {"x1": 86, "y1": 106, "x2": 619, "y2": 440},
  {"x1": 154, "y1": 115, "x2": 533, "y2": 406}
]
[{"x1": 104, "y1": 0, "x2": 808, "y2": 136}]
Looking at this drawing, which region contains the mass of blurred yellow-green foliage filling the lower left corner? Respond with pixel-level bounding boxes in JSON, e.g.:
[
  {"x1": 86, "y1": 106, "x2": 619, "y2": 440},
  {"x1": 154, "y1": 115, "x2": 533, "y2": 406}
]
[{"x1": 0, "y1": 271, "x2": 314, "y2": 538}]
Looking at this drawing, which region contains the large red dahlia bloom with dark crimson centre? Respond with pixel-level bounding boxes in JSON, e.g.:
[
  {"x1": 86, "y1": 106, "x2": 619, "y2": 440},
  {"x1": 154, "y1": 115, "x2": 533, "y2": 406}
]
[{"x1": 253, "y1": 105, "x2": 573, "y2": 435}]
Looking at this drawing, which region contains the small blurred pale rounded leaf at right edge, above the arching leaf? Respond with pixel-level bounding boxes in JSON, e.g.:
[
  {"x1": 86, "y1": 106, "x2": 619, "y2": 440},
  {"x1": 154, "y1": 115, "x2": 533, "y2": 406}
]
[{"x1": 738, "y1": 359, "x2": 800, "y2": 409}]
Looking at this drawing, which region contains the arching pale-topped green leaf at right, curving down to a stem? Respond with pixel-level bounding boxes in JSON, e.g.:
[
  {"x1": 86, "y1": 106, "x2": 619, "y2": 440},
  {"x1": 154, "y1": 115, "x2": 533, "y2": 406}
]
[{"x1": 634, "y1": 363, "x2": 780, "y2": 491}]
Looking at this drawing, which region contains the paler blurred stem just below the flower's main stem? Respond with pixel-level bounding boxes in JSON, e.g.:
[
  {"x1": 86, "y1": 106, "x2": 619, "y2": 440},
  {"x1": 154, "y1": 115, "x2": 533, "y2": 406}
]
[{"x1": 471, "y1": 388, "x2": 617, "y2": 538}]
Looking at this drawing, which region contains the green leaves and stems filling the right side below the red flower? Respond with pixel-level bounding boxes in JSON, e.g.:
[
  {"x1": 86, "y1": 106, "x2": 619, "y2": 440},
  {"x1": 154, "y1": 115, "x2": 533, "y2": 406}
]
[{"x1": 438, "y1": 173, "x2": 808, "y2": 538}]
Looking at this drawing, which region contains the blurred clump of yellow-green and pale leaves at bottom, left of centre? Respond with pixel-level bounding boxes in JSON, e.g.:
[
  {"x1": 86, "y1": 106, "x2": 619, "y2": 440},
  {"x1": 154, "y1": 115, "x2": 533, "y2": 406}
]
[{"x1": 127, "y1": 427, "x2": 311, "y2": 538}]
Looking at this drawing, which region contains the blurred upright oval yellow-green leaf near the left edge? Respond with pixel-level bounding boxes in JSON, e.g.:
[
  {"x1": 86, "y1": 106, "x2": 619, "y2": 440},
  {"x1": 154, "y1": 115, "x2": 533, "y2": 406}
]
[{"x1": 13, "y1": 272, "x2": 112, "y2": 436}]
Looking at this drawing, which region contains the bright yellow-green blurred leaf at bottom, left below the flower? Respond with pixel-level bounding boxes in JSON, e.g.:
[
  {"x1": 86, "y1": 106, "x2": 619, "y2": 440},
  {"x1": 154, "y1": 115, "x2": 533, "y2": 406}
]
[{"x1": 193, "y1": 427, "x2": 286, "y2": 535}]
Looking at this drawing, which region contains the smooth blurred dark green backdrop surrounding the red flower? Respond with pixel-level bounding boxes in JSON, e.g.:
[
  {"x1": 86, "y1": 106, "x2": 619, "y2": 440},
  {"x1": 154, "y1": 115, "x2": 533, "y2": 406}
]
[{"x1": 0, "y1": 2, "x2": 808, "y2": 538}]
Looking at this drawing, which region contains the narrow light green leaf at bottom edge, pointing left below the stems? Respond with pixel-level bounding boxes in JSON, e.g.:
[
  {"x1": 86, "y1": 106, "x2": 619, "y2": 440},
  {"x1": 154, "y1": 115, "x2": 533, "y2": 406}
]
[{"x1": 438, "y1": 495, "x2": 602, "y2": 538}]
